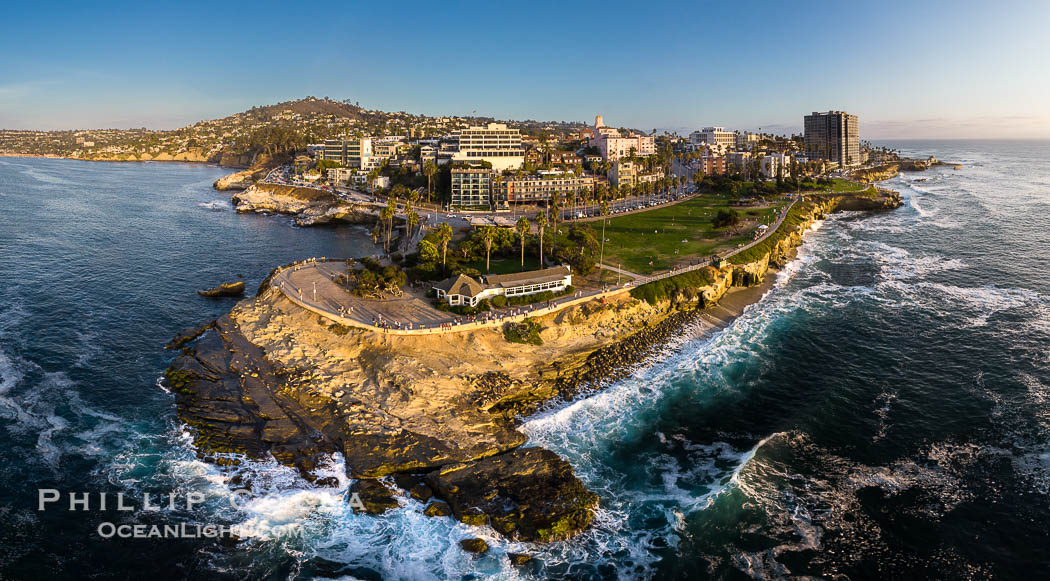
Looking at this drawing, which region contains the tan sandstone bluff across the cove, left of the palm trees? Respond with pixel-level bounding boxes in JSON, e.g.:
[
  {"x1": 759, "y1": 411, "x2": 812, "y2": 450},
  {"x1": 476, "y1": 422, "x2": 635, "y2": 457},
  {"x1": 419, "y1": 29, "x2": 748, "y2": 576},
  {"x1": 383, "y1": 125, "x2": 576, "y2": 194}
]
[{"x1": 232, "y1": 183, "x2": 378, "y2": 226}]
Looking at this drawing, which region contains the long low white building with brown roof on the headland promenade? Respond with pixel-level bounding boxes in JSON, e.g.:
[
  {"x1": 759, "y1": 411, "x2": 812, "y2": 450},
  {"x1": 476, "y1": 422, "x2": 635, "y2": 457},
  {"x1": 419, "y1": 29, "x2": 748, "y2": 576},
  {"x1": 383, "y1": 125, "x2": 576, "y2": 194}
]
[{"x1": 434, "y1": 266, "x2": 572, "y2": 307}]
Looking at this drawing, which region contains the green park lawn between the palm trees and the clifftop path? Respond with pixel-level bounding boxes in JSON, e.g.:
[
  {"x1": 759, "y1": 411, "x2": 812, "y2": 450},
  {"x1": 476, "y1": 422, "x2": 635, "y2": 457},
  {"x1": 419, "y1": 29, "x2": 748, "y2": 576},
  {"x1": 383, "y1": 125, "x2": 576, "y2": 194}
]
[{"x1": 590, "y1": 194, "x2": 785, "y2": 274}]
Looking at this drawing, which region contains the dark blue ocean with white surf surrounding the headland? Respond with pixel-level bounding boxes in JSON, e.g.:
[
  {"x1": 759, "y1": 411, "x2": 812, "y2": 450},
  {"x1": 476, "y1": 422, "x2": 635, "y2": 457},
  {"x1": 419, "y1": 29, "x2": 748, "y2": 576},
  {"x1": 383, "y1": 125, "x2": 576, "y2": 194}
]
[{"x1": 0, "y1": 141, "x2": 1050, "y2": 579}]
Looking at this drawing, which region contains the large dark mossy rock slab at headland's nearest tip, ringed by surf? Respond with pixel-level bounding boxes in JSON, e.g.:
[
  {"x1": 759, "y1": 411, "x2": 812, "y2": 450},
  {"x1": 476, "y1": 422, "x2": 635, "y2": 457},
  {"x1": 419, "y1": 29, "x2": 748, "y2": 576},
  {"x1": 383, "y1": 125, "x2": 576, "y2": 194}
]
[{"x1": 426, "y1": 448, "x2": 597, "y2": 542}]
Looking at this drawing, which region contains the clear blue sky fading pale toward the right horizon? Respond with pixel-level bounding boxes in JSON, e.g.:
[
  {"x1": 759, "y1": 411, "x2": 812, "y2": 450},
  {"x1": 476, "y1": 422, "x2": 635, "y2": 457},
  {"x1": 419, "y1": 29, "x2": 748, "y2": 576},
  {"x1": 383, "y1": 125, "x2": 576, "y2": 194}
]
[{"x1": 0, "y1": 0, "x2": 1050, "y2": 140}]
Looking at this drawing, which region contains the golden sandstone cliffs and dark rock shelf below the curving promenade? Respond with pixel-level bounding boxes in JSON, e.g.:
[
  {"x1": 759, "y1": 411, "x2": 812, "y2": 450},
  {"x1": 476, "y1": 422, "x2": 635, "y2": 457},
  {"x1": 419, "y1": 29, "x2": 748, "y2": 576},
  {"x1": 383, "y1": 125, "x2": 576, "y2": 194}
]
[{"x1": 165, "y1": 189, "x2": 901, "y2": 542}]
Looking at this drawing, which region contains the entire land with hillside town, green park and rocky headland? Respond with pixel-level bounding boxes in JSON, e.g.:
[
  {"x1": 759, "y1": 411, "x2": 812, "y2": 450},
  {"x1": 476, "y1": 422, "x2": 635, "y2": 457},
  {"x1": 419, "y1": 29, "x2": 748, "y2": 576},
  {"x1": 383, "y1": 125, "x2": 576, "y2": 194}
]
[{"x1": 0, "y1": 98, "x2": 919, "y2": 560}]
